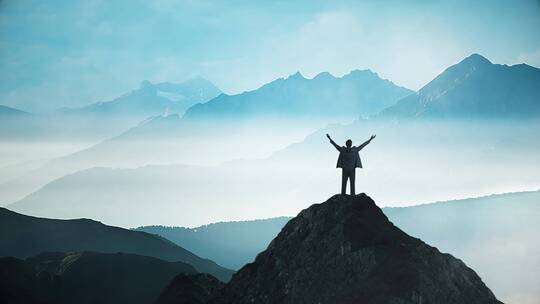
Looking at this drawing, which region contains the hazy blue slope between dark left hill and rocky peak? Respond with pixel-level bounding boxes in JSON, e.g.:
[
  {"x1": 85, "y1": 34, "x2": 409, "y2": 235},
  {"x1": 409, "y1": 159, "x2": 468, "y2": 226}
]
[{"x1": 135, "y1": 217, "x2": 290, "y2": 269}]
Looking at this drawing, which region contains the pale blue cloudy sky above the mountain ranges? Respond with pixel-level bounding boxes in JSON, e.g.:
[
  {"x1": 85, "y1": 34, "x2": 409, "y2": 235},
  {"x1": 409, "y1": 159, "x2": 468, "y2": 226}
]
[{"x1": 0, "y1": 0, "x2": 540, "y2": 112}]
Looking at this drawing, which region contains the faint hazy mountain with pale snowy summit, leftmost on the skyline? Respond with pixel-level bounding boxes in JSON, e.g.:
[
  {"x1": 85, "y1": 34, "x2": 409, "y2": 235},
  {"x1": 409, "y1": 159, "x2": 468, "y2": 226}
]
[{"x1": 0, "y1": 77, "x2": 221, "y2": 141}]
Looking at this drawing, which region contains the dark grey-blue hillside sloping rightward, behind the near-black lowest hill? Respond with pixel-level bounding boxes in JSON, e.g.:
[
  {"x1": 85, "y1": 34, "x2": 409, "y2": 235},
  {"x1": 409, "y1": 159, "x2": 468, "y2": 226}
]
[{"x1": 0, "y1": 208, "x2": 232, "y2": 281}]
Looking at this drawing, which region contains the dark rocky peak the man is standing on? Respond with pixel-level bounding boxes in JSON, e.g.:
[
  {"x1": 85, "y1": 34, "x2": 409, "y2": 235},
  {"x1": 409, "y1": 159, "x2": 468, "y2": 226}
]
[{"x1": 161, "y1": 194, "x2": 501, "y2": 304}]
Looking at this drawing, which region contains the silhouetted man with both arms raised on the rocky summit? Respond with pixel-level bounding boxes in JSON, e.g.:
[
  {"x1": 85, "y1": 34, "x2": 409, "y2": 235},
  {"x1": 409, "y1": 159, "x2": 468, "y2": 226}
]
[{"x1": 326, "y1": 134, "x2": 376, "y2": 195}]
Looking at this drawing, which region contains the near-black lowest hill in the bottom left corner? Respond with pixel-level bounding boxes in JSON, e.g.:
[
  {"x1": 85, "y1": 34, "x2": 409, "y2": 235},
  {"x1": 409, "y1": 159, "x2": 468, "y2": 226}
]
[{"x1": 0, "y1": 252, "x2": 197, "y2": 304}]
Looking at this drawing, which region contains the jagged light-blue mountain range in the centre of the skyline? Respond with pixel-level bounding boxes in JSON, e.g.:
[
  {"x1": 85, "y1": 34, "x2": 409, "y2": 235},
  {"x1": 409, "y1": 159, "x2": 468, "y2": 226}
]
[{"x1": 101, "y1": 70, "x2": 414, "y2": 144}]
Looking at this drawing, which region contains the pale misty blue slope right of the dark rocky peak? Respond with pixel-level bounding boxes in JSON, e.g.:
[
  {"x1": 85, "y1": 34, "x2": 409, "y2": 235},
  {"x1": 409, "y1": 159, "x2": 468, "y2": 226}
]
[{"x1": 383, "y1": 191, "x2": 540, "y2": 304}]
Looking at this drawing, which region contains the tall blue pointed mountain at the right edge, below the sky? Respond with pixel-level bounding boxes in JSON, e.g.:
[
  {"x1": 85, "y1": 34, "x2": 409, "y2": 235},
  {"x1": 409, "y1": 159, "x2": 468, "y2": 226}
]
[{"x1": 381, "y1": 54, "x2": 540, "y2": 119}]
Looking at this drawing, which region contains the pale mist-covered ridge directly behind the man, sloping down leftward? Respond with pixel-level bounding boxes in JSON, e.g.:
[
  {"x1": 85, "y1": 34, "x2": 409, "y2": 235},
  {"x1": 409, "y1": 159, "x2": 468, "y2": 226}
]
[{"x1": 7, "y1": 117, "x2": 540, "y2": 228}]
